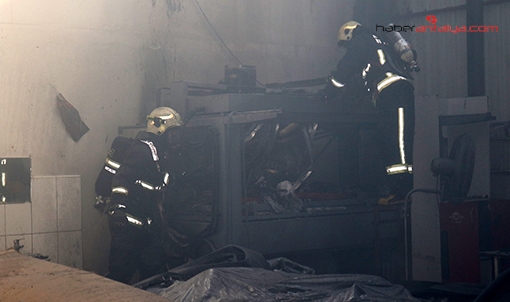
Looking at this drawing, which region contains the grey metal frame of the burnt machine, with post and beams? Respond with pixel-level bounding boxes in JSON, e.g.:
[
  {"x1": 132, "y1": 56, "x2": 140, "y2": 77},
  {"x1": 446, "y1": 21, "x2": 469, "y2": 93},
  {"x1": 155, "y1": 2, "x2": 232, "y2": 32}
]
[{"x1": 123, "y1": 82, "x2": 403, "y2": 273}]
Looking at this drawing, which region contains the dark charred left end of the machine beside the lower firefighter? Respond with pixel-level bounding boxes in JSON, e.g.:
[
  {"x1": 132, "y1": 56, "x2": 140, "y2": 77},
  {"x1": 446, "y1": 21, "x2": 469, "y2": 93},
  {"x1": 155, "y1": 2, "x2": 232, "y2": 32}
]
[{"x1": 164, "y1": 127, "x2": 219, "y2": 258}]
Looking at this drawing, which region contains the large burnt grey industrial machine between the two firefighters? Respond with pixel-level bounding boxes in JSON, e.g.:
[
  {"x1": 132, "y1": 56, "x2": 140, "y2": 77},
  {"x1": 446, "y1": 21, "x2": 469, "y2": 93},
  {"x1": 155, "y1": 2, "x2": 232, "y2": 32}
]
[{"x1": 119, "y1": 78, "x2": 403, "y2": 275}]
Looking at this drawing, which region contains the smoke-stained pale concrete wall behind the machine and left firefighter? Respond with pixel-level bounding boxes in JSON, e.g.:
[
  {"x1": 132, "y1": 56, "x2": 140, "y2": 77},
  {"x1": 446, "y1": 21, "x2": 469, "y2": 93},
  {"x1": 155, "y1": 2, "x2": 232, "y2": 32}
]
[{"x1": 0, "y1": 0, "x2": 353, "y2": 273}]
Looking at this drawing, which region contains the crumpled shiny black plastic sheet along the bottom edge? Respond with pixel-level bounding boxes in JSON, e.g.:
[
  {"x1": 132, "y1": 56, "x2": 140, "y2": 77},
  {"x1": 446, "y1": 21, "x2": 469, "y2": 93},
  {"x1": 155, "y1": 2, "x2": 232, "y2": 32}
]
[{"x1": 150, "y1": 267, "x2": 420, "y2": 302}]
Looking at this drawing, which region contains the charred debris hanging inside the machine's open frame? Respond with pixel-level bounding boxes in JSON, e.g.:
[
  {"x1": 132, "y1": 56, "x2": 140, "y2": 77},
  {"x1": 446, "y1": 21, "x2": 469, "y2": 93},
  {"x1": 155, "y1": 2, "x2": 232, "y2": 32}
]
[{"x1": 244, "y1": 122, "x2": 317, "y2": 213}]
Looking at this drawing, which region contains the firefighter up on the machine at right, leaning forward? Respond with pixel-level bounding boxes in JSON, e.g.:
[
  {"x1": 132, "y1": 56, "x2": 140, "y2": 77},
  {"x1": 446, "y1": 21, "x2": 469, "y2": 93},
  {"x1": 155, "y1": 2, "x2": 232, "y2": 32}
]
[{"x1": 321, "y1": 21, "x2": 415, "y2": 201}]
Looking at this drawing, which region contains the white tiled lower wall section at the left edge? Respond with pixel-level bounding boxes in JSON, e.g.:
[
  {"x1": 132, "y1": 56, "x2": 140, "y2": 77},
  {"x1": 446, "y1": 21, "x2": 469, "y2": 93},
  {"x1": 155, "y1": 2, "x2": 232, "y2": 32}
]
[{"x1": 0, "y1": 175, "x2": 83, "y2": 269}]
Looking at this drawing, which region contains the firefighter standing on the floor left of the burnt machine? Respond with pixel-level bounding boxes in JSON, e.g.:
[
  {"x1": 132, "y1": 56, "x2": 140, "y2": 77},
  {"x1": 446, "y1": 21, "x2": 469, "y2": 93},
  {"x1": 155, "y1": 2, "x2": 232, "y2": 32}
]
[{"x1": 106, "y1": 107, "x2": 183, "y2": 283}]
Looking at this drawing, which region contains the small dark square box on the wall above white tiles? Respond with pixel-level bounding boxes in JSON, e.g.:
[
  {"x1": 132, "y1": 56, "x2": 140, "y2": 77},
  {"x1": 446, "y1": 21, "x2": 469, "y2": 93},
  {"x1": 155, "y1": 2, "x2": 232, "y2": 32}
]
[{"x1": 0, "y1": 157, "x2": 31, "y2": 203}]
